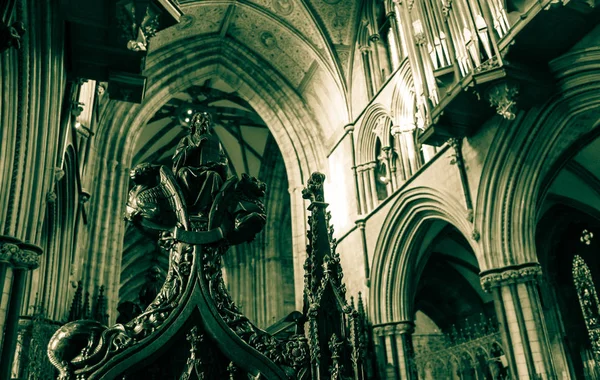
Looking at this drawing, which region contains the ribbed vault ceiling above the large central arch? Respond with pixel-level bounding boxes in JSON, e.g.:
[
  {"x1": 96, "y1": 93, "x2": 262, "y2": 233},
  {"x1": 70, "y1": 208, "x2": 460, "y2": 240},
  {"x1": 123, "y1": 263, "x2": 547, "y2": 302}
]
[{"x1": 149, "y1": 0, "x2": 360, "y2": 134}]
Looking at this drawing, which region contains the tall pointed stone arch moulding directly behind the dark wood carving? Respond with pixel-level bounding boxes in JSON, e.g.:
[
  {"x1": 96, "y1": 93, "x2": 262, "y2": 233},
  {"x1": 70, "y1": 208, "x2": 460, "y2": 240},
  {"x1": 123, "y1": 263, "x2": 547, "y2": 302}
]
[{"x1": 84, "y1": 38, "x2": 325, "y2": 316}]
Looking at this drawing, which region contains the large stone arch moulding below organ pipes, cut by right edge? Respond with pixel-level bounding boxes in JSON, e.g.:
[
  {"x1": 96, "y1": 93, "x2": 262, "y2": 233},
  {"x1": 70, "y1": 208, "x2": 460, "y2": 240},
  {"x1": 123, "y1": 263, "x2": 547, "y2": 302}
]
[{"x1": 474, "y1": 47, "x2": 600, "y2": 269}]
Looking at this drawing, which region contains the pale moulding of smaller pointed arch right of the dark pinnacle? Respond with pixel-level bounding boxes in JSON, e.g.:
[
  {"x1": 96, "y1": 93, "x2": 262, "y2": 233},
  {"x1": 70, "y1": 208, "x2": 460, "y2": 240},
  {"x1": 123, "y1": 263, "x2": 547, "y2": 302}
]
[{"x1": 369, "y1": 187, "x2": 482, "y2": 324}]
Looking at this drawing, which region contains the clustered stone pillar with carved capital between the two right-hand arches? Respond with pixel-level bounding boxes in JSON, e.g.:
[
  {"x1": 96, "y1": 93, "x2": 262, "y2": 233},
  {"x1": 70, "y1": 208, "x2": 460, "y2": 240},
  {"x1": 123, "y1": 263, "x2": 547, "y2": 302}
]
[{"x1": 481, "y1": 263, "x2": 556, "y2": 379}]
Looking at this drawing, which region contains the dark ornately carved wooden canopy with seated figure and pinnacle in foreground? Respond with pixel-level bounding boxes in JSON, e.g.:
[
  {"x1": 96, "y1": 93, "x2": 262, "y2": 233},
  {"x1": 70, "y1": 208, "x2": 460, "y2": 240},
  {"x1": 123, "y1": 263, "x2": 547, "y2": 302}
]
[{"x1": 48, "y1": 113, "x2": 364, "y2": 380}]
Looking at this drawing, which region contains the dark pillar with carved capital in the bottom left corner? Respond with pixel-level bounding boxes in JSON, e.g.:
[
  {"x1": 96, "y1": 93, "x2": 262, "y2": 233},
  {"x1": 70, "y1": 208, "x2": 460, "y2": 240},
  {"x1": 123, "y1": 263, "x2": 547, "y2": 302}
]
[{"x1": 0, "y1": 237, "x2": 42, "y2": 379}]
